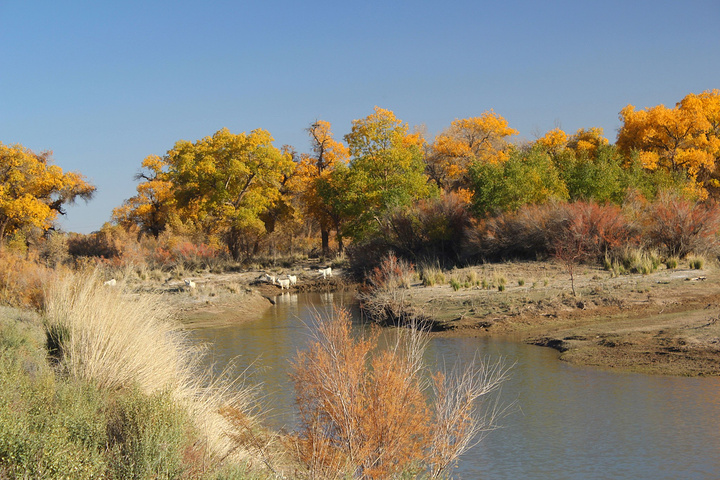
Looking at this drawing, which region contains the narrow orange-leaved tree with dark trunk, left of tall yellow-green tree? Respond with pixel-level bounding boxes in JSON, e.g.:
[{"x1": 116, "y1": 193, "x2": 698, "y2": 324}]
[{"x1": 293, "y1": 120, "x2": 350, "y2": 255}]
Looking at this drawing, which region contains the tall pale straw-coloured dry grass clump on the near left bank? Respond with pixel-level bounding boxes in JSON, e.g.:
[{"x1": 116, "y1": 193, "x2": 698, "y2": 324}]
[{"x1": 44, "y1": 272, "x2": 254, "y2": 458}]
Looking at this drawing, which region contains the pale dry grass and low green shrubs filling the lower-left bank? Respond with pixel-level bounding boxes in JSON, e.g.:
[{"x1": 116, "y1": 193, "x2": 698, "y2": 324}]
[{"x1": 0, "y1": 274, "x2": 264, "y2": 478}]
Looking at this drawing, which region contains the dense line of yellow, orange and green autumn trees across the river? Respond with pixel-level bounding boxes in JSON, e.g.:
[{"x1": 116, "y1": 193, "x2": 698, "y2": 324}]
[{"x1": 0, "y1": 90, "x2": 720, "y2": 276}]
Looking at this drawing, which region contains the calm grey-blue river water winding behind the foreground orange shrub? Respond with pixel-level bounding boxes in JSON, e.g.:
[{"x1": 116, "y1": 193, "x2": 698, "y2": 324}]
[{"x1": 193, "y1": 293, "x2": 720, "y2": 480}]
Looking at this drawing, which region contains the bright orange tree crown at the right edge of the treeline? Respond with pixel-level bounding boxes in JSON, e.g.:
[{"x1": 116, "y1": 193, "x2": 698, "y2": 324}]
[{"x1": 617, "y1": 90, "x2": 720, "y2": 197}]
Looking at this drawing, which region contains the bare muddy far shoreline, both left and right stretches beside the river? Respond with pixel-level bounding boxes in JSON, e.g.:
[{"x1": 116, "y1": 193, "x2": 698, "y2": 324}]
[{"x1": 135, "y1": 262, "x2": 720, "y2": 376}]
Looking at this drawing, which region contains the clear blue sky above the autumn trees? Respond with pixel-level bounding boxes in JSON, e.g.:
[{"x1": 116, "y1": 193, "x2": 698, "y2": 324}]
[{"x1": 0, "y1": 0, "x2": 720, "y2": 233}]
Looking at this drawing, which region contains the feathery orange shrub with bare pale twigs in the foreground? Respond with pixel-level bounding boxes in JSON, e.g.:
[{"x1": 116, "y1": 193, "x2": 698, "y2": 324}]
[{"x1": 291, "y1": 310, "x2": 508, "y2": 479}]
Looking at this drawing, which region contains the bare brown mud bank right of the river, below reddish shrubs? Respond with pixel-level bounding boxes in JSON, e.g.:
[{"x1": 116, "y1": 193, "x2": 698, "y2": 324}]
[{"x1": 386, "y1": 262, "x2": 720, "y2": 376}]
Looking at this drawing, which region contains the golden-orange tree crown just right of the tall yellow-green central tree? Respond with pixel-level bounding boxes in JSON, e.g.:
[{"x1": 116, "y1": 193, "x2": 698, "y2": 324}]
[{"x1": 426, "y1": 110, "x2": 518, "y2": 191}]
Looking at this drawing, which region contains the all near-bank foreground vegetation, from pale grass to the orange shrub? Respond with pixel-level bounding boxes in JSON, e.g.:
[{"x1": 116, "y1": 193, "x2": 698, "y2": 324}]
[{"x1": 0, "y1": 271, "x2": 508, "y2": 479}]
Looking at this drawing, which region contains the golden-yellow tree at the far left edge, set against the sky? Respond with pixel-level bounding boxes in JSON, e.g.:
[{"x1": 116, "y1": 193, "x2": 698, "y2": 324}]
[{"x1": 0, "y1": 143, "x2": 95, "y2": 242}]
